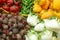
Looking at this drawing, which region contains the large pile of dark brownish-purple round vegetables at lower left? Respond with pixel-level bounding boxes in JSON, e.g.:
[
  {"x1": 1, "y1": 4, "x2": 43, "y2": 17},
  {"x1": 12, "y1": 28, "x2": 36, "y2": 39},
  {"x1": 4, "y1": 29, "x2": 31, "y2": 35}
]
[{"x1": 0, "y1": 13, "x2": 30, "y2": 40}]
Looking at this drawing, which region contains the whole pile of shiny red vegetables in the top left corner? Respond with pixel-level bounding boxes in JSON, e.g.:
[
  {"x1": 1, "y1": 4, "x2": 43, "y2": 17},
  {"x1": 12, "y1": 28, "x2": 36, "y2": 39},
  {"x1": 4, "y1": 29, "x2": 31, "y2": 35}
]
[{"x1": 0, "y1": 0, "x2": 22, "y2": 13}]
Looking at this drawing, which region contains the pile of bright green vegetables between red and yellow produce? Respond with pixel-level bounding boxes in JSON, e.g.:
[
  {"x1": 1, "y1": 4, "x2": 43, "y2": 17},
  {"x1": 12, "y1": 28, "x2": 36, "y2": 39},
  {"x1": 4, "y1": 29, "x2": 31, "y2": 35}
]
[{"x1": 20, "y1": 0, "x2": 34, "y2": 14}]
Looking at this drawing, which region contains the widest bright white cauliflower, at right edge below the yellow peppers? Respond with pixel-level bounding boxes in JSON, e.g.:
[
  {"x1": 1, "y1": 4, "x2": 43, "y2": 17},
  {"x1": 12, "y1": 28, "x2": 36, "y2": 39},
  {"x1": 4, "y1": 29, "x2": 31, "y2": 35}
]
[{"x1": 44, "y1": 19, "x2": 60, "y2": 30}]
